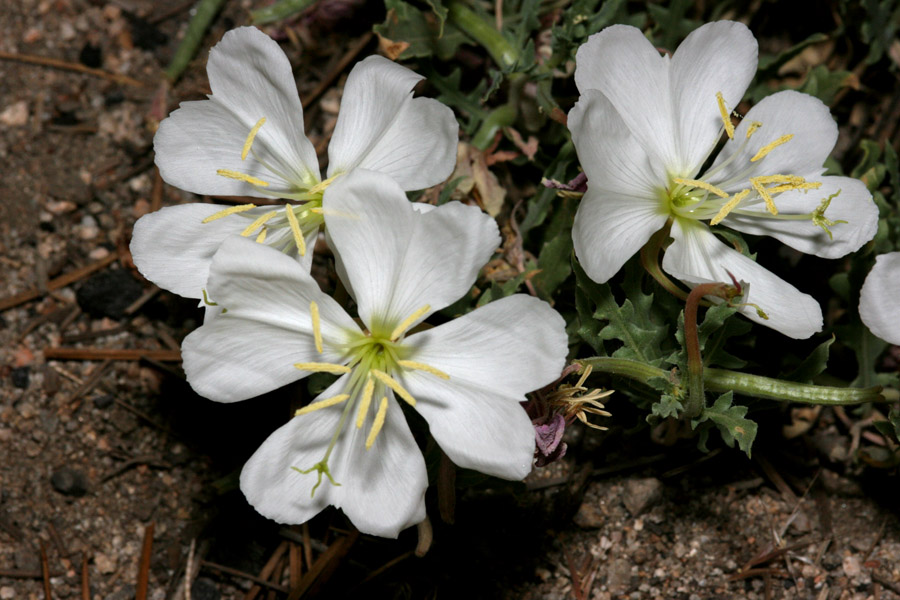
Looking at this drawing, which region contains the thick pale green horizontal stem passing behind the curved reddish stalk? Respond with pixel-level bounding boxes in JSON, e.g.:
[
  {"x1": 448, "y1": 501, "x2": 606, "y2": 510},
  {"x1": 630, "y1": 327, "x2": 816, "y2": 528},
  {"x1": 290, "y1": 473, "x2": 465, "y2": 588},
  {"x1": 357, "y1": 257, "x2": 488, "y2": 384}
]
[{"x1": 577, "y1": 356, "x2": 884, "y2": 406}]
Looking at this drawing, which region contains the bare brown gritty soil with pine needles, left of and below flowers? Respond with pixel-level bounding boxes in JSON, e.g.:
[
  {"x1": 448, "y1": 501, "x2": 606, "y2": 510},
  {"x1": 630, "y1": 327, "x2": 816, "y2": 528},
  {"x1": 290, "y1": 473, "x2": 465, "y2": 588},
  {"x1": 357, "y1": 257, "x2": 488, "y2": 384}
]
[{"x1": 0, "y1": 0, "x2": 900, "y2": 600}]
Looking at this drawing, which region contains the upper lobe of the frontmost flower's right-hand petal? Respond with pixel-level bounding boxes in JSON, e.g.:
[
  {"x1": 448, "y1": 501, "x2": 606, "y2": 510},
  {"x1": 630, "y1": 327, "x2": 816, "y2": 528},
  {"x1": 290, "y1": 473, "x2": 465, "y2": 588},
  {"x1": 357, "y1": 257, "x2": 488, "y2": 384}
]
[{"x1": 404, "y1": 294, "x2": 568, "y2": 400}]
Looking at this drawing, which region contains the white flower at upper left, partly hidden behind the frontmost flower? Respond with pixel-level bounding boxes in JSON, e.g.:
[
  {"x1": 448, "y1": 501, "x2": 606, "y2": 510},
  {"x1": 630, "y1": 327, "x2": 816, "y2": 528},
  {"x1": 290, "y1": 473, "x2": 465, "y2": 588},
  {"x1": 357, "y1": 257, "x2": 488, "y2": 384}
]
[{"x1": 131, "y1": 27, "x2": 458, "y2": 298}]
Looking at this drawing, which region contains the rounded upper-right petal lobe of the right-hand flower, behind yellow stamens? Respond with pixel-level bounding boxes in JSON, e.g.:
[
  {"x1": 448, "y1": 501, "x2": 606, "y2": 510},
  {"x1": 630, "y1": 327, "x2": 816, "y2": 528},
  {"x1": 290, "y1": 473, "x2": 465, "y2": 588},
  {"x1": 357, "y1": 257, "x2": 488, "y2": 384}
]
[{"x1": 709, "y1": 90, "x2": 838, "y2": 186}]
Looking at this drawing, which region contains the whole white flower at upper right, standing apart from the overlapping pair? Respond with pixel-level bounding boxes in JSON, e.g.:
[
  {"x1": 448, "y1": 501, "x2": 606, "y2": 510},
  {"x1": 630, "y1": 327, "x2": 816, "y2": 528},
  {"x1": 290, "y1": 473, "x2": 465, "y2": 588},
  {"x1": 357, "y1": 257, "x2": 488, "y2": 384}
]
[{"x1": 569, "y1": 21, "x2": 878, "y2": 338}]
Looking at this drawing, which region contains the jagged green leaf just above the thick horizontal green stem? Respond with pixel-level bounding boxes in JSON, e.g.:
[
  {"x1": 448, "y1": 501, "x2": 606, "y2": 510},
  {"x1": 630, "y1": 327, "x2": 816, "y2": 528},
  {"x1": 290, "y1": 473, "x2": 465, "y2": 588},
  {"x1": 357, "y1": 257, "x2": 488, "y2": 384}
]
[{"x1": 575, "y1": 263, "x2": 669, "y2": 366}]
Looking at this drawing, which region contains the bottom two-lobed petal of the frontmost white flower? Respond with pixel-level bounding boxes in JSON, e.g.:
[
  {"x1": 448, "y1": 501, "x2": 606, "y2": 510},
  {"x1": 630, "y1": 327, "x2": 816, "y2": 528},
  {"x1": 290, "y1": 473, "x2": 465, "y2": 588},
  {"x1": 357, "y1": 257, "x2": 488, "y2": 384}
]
[{"x1": 241, "y1": 376, "x2": 428, "y2": 537}]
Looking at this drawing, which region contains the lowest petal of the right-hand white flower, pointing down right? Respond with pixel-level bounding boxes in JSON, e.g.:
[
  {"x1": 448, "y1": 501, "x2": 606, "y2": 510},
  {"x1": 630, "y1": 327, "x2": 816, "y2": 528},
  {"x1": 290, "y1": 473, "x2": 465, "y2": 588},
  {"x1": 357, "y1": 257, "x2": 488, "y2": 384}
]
[{"x1": 662, "y1": 220, "x2": 822, "y2": 339}]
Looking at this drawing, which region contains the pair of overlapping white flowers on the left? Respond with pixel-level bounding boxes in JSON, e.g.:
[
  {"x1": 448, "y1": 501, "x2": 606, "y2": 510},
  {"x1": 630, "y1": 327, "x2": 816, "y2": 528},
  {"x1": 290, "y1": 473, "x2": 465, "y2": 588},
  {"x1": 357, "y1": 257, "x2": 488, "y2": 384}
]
[{"x1": 132, "y1": 28, "x2": 567, "y2": 537}]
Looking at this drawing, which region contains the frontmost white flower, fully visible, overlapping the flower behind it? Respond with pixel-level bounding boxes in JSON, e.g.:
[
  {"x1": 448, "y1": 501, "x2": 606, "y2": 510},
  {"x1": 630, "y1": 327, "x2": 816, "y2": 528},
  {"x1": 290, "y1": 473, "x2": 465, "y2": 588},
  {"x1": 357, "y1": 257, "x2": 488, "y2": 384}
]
[{"x1": 183, "y1": 169, "x2": 567, "y2": 537}]
